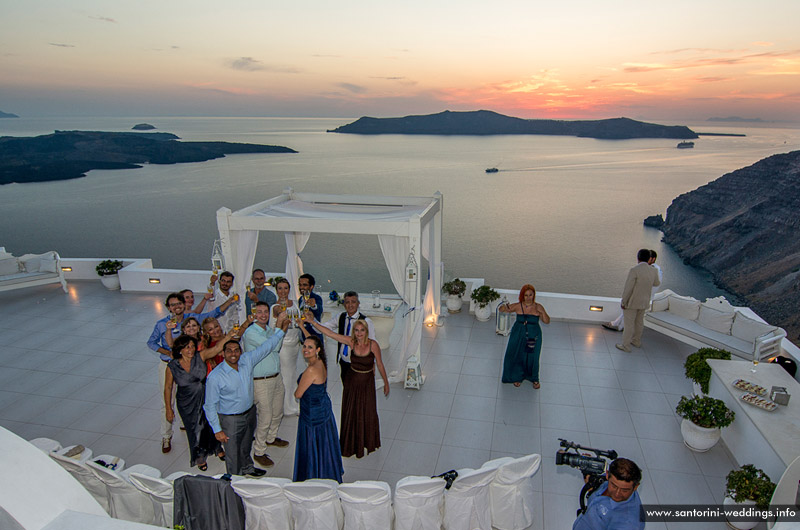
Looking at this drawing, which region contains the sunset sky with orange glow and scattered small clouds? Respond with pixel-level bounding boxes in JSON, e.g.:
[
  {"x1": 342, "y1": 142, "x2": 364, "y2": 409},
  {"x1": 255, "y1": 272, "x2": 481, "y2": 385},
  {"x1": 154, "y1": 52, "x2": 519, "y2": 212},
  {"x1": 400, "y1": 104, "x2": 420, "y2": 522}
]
[{"x1": 0, "y1": 0, "x2": 800, "y2": 122}]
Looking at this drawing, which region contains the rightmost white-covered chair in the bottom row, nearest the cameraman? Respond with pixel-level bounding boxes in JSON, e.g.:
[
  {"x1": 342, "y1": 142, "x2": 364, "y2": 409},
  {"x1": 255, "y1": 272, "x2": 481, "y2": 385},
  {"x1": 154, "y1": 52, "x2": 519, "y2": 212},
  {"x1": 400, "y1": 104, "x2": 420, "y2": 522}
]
[{"x1": 484, "y1": 454, "x2": 542, "y2": 530}]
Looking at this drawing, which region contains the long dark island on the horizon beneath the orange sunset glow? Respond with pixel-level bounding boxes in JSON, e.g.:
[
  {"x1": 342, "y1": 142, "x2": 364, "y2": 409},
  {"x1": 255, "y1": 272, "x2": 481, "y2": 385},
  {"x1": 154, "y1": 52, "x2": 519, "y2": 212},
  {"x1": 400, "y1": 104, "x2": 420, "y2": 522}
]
[{"x1": 328, "y1": 110, "x2": 698, "y2": 140}]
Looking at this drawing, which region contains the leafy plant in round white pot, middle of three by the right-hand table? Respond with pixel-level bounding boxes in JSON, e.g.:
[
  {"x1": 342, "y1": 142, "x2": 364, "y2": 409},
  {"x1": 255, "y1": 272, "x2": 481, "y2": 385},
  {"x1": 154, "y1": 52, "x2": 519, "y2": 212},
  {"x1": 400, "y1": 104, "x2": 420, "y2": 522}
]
[{"x1": 675, "y1": 396, "x2": 736, "y2": 453}]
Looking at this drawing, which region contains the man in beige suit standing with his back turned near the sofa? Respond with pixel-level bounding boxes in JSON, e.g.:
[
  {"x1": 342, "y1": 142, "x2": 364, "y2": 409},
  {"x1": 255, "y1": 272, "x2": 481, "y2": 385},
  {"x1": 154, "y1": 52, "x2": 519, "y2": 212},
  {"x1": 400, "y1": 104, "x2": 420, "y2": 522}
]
[{"x1": 616, "y1": 248, "x2": 661, "y2": 352}]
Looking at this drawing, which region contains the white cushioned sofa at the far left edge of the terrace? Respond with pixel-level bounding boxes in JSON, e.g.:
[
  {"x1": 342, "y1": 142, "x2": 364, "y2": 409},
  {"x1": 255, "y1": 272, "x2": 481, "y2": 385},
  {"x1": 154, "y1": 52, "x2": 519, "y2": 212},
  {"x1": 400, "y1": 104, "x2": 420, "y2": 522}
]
[{"x1": 0, "y1": 247, "x2": 67, "y2": 293}]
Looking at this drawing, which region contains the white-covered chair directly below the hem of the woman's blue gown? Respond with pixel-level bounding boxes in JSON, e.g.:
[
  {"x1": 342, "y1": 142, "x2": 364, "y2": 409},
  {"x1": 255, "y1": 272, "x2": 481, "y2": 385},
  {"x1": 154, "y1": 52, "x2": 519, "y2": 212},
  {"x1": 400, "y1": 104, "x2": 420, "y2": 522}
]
[{"x1": 283, "y1": 479, "x2": 344, "y2": 530}]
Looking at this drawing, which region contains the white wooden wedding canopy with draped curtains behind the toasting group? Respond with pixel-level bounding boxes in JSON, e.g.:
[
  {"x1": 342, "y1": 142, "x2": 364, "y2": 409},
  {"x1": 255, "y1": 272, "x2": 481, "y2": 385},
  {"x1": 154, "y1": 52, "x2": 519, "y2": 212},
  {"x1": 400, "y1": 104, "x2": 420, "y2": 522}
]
[{"x1": 217, "y1": 188, "x2": 442, "y2": 382}]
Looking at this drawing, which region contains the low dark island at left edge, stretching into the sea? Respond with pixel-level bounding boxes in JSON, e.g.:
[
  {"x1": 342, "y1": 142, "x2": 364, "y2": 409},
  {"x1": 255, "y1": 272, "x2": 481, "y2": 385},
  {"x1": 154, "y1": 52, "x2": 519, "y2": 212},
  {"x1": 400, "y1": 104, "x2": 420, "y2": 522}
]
[{"x1": 0, "y1": 131, "x2": 297, "y2": 185}]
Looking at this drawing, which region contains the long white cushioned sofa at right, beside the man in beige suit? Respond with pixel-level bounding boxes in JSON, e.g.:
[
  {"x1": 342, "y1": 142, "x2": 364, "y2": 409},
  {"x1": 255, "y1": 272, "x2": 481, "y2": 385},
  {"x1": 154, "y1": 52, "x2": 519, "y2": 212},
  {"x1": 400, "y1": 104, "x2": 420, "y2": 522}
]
[{"x1": 644, "y1": 289, "x2": 786, "y2": 360}]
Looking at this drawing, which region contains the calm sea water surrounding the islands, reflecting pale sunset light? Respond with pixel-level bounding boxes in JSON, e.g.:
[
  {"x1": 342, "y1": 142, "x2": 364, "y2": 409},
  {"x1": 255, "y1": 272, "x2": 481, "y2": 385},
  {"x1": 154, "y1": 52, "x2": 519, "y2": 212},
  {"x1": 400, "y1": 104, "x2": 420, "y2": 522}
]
[{"x1": 0, "y1": 117, "x2": 800, "y2": 298}]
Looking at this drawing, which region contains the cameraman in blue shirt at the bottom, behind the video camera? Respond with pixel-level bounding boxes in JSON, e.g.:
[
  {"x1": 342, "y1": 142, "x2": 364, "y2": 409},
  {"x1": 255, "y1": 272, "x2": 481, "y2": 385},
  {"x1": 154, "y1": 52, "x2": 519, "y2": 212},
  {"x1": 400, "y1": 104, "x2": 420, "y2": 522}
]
[{"x1": 572, "y1": 458, "x2": 644, "y2": 530}]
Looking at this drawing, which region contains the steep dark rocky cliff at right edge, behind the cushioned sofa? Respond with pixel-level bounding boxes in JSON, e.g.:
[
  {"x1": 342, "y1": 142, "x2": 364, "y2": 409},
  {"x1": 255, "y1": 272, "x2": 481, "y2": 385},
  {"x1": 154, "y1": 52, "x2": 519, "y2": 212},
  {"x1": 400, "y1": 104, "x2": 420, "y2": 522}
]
[{"x1": 662, "y1": 151, "x2": 800, "y2": 338}]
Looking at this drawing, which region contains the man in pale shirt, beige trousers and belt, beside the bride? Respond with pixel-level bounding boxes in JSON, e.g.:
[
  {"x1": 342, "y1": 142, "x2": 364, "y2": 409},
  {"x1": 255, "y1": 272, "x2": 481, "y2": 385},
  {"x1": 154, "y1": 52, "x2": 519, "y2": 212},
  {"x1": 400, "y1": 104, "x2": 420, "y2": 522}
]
[{"x1": 242, "y1": 302, "x2": 296, "y2": 467}]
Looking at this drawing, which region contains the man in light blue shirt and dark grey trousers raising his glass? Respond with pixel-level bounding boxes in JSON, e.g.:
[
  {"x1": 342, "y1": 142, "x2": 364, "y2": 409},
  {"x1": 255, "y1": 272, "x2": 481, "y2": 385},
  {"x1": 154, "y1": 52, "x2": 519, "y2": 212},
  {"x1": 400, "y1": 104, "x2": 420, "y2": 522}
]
[{"x1": 203, "y1": 314, "x2": 288, "y2": 477}]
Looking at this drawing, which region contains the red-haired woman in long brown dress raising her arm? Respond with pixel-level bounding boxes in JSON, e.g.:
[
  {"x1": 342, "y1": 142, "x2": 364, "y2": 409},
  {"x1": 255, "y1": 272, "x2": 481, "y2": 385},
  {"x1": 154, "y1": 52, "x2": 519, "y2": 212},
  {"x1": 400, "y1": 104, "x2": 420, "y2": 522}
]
[{"x1": 306, "y1": 312, "x2": 389, "y2": 458}]
